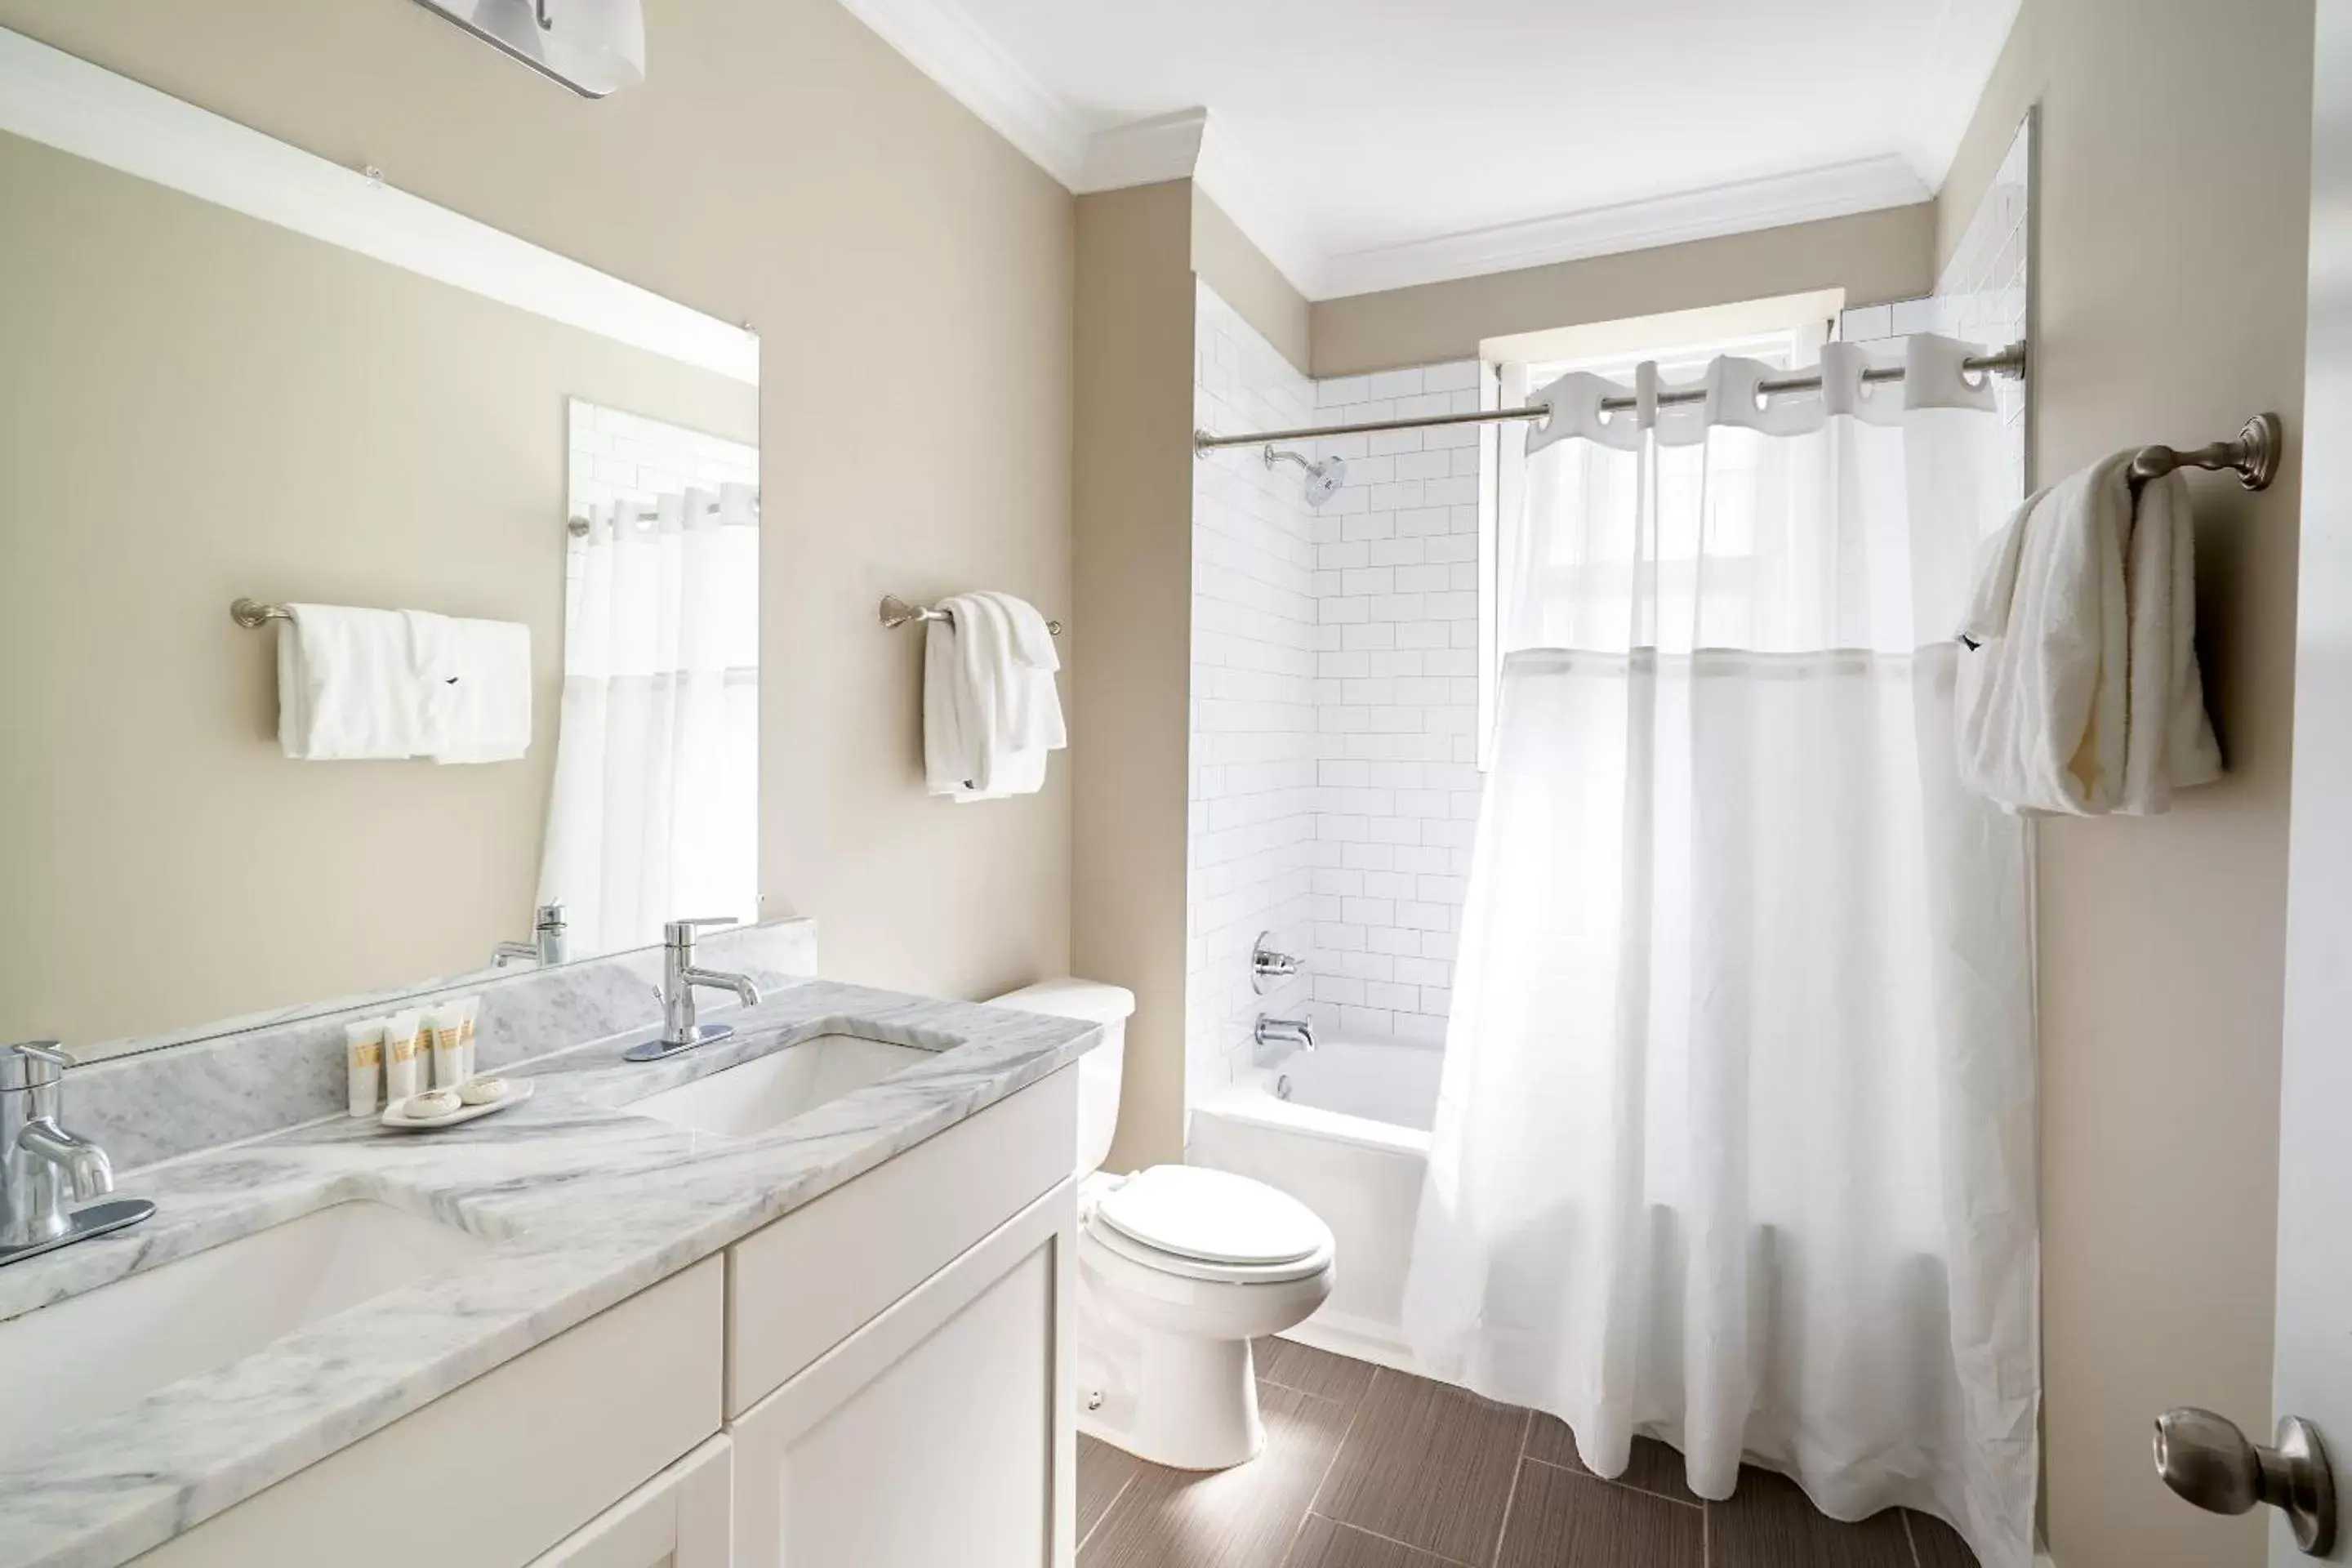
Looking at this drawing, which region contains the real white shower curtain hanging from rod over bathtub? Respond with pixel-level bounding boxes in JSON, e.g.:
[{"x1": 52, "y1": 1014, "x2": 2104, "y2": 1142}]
[{"x1": 1406, "y1": 339, "x2": 2039, "y2": 1568}]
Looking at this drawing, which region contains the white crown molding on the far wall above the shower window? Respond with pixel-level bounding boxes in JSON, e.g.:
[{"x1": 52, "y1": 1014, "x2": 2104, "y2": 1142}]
[{"x1": 1315, "y1": 155, "x2": 1933, "y2": 299}]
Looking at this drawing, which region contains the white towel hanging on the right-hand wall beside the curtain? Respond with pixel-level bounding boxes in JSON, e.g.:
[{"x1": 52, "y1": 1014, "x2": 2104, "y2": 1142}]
[{"x1": 1957, "y1": 452, "x2": 2221, "y2": 816}]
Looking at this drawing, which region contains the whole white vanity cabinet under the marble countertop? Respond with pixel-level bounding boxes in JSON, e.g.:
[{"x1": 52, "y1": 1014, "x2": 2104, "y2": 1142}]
[{"x1": 126, "y1": 1067, "x2": 1077, "y2": 1568}]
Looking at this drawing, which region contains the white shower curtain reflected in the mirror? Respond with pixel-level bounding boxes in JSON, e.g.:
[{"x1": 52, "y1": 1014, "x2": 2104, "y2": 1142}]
[{"x1": 539, "y1": 484, "x2": 760, "y2": 952}]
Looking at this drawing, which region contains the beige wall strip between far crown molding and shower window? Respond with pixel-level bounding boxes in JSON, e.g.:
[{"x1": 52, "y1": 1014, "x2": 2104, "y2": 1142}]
[{"x1": 1312, "y1": 203, "x2": 1936, "y2": 376}]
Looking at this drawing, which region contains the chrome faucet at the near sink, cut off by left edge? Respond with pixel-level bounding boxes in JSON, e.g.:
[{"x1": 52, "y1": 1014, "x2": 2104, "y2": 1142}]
[{"x1": 0, "y1": 1039, "x2": 155, "y2": 1265}]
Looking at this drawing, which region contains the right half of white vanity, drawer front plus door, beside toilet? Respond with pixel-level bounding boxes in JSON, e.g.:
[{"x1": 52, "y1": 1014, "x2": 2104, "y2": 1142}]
[{"x1": 727, "y1": 1070, "x2": 1077, "y2": 1568}]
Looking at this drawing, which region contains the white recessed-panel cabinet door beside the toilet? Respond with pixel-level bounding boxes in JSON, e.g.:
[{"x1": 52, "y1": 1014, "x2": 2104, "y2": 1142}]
[{"x1": 734, "y1": 1180, "x2": 1077, "y2": 1568}]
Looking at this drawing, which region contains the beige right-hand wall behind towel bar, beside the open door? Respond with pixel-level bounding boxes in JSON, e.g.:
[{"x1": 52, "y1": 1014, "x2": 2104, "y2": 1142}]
[{"x1": 1938, "y1": 0, "x2": 2312, "y2": 1568}]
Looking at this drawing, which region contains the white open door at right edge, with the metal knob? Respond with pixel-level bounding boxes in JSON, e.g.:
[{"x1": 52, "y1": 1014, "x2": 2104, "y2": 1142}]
[{"x1": 2248, "y1": 5, "x2": 2352, "y2": 1566}]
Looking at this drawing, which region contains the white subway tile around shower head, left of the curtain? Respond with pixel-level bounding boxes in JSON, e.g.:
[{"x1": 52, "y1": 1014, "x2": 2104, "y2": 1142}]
[{"x1": 1186, "y1": 287, "x2": 1481, "y2": 1094}]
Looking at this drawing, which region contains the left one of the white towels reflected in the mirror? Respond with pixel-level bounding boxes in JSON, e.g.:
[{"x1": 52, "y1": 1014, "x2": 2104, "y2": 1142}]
[{"x1": 278, "y1": 604, "x2": 425, "y2": 762}]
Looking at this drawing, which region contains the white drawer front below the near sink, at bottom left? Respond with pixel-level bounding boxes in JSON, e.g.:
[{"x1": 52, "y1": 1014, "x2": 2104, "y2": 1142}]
[{"x1": 139, "y1": 1258, "x2": 724, "y2": 1568}]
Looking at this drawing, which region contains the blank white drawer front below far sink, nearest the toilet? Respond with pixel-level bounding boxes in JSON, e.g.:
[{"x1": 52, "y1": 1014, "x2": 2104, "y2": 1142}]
[{"x1": 727, "y1": 1067, "x2": 1077, "y2": 1418}]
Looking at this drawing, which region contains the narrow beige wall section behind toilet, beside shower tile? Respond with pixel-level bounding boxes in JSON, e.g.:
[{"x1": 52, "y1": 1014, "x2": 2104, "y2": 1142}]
[{"x1": 1070, "y1": 181, "x2": 1195, "y2": 1171}]
